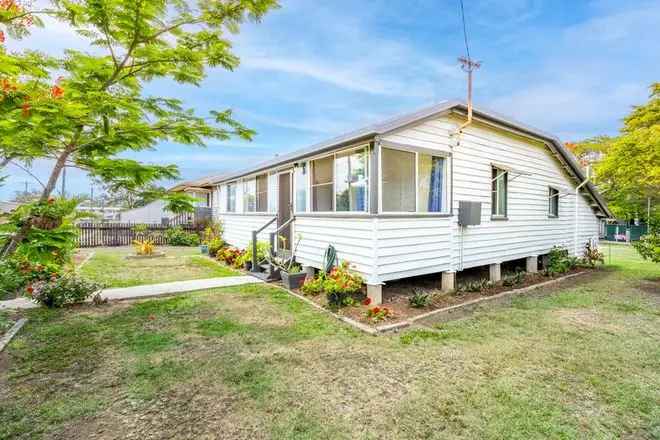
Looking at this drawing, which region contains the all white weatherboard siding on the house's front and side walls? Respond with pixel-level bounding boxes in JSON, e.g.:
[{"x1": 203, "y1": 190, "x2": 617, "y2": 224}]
[{"x1": 213, "y1": 112, "x2": 599, "y2": 284}]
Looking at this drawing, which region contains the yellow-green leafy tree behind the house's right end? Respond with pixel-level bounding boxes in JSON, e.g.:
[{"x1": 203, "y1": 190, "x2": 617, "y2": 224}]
[{"x1": 575, "y1": 83, "x2": 660, "y2": 222}]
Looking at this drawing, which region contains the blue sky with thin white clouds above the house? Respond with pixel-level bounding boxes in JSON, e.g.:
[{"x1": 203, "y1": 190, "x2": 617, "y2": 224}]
[{"x1": 0, "y1": 0, "x2": 660, "y2": 199}]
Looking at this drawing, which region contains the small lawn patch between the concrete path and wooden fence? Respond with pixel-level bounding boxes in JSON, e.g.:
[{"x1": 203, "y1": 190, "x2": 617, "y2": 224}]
[{"x1": 81, "y1": 247, "x2": 237, "y2": 287}]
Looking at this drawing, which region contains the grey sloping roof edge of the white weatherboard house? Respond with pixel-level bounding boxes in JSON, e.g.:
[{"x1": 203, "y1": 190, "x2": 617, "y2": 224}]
[{"x1": 172, "y1": 99, "x2": 613, "y2": 217}]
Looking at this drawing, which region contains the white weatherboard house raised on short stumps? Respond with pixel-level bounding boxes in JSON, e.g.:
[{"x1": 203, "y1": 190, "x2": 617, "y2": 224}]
[{"x1": 173, "y1": 100, "x2": 611, "y2": 303}]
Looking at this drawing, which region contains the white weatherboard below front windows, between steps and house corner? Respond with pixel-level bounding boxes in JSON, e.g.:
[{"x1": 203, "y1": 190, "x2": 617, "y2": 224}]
[{"x1": 293, "y1": 216, "x2": 375, "y2": 278}]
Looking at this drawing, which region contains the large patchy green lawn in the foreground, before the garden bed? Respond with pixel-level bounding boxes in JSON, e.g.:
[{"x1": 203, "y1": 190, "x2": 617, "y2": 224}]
[{"x1": 0, "y1": 247, "x2": 660, "y2": 439}]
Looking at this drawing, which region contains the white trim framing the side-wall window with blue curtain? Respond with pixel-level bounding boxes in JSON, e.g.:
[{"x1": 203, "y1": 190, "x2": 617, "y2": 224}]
[{"x1": 378, "y1": 142, "x2": 453, "y2": 217}]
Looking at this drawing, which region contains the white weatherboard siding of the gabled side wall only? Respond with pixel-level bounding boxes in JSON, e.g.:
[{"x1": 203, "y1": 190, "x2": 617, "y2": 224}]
[{"x1": 378, "y1": 118, "x2": 598, "y2": 280}]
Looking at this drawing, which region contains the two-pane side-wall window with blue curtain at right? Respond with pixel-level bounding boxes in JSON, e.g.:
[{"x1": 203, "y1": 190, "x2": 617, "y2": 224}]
[{"x1": 381, "y1": 148, "x2": 448, "y2": 212}]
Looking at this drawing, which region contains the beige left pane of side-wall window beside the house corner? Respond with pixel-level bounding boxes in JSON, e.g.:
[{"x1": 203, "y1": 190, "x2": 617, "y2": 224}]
[{"x1": 381, "y1": 147, "x2": 415, "y2": 212}]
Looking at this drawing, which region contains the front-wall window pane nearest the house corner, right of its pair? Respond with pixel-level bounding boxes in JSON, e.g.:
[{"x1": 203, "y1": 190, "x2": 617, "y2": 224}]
[{"x1": 335, "y1": 149, "x2": 368, "y2": 211}]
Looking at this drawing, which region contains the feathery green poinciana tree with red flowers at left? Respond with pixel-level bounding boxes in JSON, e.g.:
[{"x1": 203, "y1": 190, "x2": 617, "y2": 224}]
[{"x1": 0, "y1": 0, "x2": 277, "y2": 256}]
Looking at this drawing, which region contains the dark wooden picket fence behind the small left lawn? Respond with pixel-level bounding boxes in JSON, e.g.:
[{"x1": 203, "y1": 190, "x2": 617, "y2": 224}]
[{"x1": 78, "y1": 223, "x2": 201, "y2": 247}]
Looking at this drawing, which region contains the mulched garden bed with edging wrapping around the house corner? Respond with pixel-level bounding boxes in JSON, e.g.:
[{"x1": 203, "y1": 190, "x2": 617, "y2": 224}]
[{"x1": 288, "y1": 269, "x2": 587, "y2": 327}]
